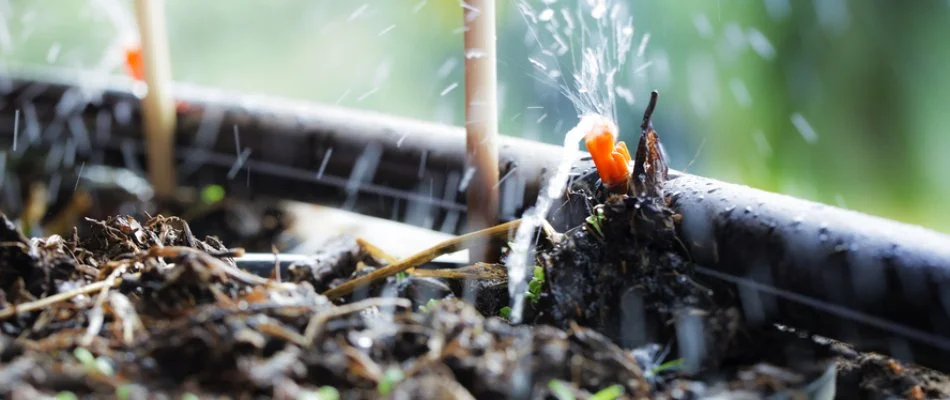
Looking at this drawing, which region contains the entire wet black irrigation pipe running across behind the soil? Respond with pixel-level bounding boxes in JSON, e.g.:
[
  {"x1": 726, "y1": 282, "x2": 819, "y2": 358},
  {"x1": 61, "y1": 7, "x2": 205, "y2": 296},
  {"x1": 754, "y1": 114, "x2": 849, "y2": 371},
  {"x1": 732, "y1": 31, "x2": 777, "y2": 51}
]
[{"x1": 0, "y1": 69, "x2": 950, "y2": 371}]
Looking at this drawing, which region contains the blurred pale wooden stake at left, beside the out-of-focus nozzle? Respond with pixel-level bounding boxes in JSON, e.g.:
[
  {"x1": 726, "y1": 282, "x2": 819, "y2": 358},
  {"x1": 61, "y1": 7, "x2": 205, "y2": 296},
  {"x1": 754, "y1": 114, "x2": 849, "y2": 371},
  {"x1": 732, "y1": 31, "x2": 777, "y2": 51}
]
[{"x1": 135, "y1": 0, "x2": 177, "y2": 198}]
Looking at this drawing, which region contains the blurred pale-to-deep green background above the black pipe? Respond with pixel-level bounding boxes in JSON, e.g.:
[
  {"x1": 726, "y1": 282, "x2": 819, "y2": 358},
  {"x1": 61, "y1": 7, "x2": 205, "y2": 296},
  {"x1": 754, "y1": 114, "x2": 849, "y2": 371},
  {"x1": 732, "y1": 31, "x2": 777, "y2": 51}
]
[{"x1": 0, "y1": 0, "x2": 950, "y2": 232}]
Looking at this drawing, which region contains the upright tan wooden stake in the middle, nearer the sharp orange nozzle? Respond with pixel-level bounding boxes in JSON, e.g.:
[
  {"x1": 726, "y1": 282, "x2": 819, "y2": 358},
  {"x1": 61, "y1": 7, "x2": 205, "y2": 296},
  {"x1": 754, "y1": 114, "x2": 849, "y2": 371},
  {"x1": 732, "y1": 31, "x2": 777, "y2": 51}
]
[{"x1": 462, "y1": 0, "x2": 498, "y2": 262}]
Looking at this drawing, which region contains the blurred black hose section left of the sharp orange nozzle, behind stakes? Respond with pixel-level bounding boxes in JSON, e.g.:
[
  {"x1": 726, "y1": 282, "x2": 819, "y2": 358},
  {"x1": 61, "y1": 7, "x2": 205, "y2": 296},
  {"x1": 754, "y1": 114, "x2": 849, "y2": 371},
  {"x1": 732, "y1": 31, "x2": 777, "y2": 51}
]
[{"x1": 0, "y1": 69, "x2": 551, "y2": 232}]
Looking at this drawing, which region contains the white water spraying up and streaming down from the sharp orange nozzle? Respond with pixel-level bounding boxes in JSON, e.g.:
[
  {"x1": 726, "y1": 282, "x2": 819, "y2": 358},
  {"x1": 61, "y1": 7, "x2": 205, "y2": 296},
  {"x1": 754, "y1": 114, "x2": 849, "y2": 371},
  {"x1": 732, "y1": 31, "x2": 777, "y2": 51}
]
[{"x1": 506, "y1": 0, "x2": 634, "y2": 323}]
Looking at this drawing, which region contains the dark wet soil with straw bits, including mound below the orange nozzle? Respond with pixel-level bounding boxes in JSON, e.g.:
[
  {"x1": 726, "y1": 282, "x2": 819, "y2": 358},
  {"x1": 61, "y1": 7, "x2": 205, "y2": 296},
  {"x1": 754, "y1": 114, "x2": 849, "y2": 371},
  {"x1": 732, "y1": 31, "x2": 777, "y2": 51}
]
[{"x1": 0, "y1": 171, "x2": 950, "y2": 399}]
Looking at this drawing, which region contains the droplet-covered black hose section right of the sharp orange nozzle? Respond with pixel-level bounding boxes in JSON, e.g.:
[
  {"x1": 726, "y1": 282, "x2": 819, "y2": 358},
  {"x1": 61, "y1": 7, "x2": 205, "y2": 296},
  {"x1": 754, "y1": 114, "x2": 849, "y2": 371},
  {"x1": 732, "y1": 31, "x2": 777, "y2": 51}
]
[{"x1": 665, "y1": 174, "x2": 950, "y2": 371}]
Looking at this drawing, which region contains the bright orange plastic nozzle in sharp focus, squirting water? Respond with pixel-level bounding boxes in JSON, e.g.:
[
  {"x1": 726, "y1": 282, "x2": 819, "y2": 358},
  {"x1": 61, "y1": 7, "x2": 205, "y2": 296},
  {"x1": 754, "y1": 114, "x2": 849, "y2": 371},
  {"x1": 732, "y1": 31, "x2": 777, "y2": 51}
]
[{"x1": 584, "y1": 121, "x2": 630, "y2": 186}]
